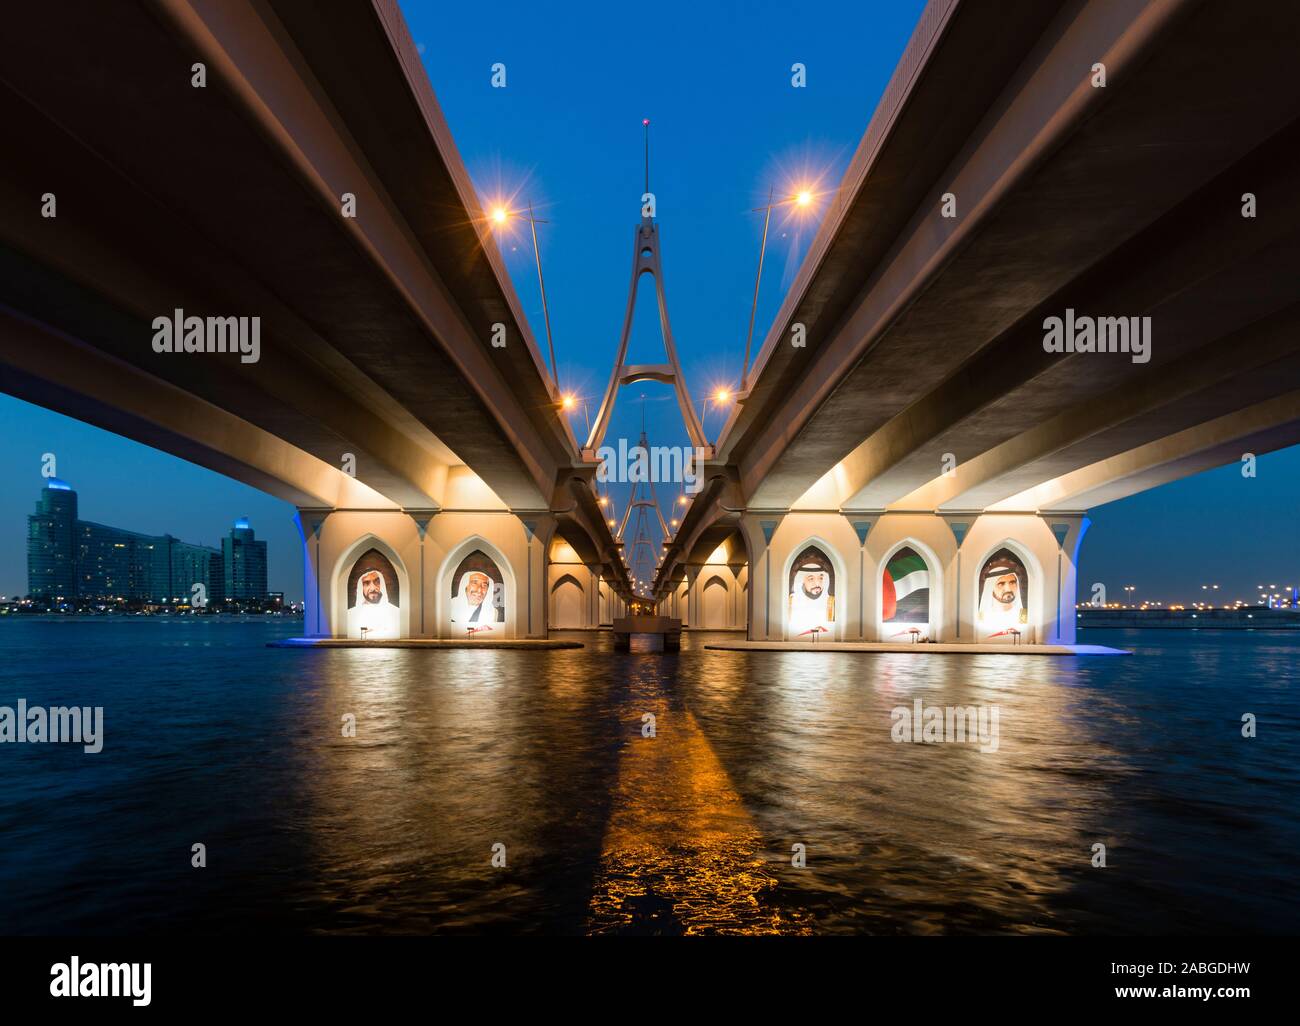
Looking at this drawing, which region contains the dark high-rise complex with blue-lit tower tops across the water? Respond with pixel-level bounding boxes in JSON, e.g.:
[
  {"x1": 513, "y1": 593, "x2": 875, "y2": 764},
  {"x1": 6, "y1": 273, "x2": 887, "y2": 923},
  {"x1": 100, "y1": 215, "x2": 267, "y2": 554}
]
[{"x1": 27, "y1": 477, "x2": 239, "y2": 603}]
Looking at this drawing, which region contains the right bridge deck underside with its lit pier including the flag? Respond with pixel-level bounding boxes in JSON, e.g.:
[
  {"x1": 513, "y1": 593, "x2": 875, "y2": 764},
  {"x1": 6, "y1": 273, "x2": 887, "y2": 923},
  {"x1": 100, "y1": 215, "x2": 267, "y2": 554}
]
[{"x1": 657, "y1": 0, "x2": 1300, "y2": 644}]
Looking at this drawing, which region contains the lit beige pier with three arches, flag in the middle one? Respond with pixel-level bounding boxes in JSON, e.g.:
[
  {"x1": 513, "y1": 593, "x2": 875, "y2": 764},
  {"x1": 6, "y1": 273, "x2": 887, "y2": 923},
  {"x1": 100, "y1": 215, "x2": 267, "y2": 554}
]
[{"x1": 738, "y1": 511, "x2": 1089, "y2": 645}]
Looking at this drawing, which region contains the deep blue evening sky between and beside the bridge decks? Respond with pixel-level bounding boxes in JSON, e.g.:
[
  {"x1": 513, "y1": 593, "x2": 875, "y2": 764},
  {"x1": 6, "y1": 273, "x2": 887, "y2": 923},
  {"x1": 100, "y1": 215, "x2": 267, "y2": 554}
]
[{"x1": 0, "y1": 0, "x2": 1300, "y2": 601}]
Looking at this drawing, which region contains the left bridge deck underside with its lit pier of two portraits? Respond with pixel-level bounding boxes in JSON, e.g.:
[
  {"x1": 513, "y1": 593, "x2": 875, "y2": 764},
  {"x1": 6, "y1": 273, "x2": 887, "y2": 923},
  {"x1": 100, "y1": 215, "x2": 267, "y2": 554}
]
[{"x1": 0, "y1": 0, "x2": 629, "y2": 637}]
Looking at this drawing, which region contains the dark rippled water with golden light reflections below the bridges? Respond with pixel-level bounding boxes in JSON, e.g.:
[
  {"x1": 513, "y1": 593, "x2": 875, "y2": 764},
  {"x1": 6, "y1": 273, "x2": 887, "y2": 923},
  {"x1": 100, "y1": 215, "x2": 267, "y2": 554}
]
[{"x1": 0, "y1": 619, "x2": 1300, "y2": 934}]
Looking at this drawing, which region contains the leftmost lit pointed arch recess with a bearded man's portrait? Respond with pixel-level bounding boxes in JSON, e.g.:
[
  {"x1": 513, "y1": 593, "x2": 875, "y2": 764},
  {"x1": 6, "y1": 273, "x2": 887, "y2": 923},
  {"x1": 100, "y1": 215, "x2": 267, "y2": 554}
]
[{"x1": 329, "y1": 533, "x2": 415, "y2": 641}]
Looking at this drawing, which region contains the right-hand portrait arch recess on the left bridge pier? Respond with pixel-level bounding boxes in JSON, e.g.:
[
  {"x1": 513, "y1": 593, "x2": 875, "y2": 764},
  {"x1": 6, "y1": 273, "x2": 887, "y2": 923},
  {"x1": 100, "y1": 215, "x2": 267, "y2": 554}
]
[{"x1": 438, "y1": 534, "x2": 517, "y2": 640}]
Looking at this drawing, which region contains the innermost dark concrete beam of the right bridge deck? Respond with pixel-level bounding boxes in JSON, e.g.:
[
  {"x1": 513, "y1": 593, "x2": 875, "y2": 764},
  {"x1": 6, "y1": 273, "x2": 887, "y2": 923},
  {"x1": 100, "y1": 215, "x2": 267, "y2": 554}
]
[{"x1": 729, "y1": 3, "x2": 1300, "y2": 508}]
